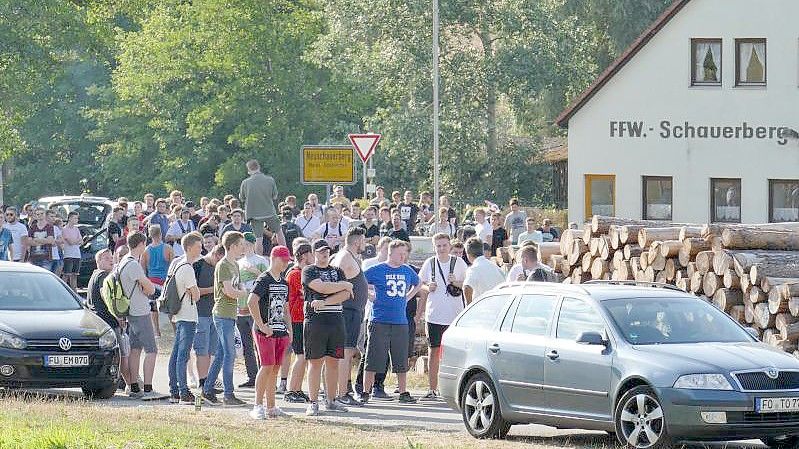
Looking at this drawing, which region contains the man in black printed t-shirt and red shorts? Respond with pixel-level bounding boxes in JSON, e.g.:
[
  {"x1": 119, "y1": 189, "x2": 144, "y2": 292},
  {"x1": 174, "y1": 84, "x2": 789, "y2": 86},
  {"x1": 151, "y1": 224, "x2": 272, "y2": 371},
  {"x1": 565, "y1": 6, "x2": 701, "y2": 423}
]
[{"x1": 247, "y1": 246, "x2": 291, "y2": 419}]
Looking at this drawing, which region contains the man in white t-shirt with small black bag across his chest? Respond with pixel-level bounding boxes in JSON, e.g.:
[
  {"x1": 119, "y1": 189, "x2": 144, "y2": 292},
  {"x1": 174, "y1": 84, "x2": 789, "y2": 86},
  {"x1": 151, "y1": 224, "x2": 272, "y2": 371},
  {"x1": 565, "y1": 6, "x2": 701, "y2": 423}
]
[{"x1": 419, "y1": 233, "x2": 467, "y2": 400}]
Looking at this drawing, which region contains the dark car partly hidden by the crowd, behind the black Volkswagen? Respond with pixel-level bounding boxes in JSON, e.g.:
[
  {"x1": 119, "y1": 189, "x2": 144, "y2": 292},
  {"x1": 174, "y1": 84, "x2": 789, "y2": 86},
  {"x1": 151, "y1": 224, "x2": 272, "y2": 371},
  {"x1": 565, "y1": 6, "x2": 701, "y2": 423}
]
[{"x1": 36, "y1": 195, "x2": 114, "y2": 287}]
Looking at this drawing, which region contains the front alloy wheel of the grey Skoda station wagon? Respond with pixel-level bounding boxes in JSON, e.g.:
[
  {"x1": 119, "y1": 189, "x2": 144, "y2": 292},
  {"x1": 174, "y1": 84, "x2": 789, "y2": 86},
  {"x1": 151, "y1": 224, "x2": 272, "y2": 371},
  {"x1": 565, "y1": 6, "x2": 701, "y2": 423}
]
[{"x1": 616, "y1": 386, "x2": 668, "y2": 449}]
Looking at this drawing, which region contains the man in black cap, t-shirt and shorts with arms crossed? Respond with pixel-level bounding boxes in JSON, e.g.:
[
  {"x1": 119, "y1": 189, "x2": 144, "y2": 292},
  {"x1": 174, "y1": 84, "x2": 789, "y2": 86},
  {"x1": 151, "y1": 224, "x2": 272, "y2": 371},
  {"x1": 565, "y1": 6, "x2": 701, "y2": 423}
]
[{"x1": 302, "y1": 239, "x2": 352, "y2": 416}]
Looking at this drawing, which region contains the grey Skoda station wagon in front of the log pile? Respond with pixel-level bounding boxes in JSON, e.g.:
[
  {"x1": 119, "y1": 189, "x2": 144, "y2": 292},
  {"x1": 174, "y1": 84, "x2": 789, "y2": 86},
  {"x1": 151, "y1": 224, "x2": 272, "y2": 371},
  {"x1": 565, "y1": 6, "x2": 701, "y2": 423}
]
[{"x1": 439, "y1": 281, "x2": 799, "y2": 449}]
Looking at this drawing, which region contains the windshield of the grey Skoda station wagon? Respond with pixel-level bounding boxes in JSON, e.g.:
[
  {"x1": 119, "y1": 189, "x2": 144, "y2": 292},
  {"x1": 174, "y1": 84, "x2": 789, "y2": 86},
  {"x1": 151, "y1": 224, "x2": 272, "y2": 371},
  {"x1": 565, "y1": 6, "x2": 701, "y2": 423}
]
[{"x1": 602, "y1": 297, "x2": 752, "y2": 345}]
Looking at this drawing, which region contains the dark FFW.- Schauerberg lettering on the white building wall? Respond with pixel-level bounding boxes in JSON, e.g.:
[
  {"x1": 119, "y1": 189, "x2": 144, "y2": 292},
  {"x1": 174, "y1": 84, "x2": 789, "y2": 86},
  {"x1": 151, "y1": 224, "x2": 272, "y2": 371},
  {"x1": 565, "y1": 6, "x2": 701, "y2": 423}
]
[{"x1": 610, "y1": 120, "x2": 792, "y2": 145}]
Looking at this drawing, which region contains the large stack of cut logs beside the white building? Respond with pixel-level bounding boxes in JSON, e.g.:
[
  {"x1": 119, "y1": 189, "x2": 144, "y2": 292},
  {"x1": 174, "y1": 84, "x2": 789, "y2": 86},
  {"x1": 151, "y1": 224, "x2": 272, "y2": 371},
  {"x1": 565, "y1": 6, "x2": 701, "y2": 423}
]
[{"x1": 543, "y1": 215, "x2": 799, "y2": 357}]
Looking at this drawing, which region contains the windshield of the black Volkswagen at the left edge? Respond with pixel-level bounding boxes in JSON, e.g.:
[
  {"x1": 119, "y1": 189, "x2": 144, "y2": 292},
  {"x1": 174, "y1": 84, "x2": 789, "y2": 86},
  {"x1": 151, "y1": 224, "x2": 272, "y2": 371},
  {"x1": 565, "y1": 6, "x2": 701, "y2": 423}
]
[{"x1": 0, "y1": 271, "x2": 81, "y2": 311}]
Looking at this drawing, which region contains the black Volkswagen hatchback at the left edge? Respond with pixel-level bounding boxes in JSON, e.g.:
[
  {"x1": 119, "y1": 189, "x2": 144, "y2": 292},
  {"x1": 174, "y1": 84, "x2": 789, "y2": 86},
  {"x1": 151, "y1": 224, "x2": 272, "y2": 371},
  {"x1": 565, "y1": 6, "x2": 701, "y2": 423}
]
[{"x1": 0, "y1": 262, "x2": 120, "y2": 399}]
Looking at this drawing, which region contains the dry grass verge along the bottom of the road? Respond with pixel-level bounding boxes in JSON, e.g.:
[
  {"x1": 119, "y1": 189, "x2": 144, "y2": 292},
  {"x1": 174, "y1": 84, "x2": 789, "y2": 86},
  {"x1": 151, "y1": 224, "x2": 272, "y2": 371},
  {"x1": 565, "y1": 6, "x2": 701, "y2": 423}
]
[{"x1": 0, "y1": 397, "x2": 612, "y2": 449}]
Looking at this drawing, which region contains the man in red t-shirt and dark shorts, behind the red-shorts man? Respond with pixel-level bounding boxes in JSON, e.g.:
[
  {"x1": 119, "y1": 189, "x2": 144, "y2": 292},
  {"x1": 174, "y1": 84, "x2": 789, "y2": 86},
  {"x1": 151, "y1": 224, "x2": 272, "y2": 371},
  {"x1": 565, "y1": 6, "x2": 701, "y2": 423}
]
[{"x1": 283, "y1": 240, "x2": 314, "y2": 403}]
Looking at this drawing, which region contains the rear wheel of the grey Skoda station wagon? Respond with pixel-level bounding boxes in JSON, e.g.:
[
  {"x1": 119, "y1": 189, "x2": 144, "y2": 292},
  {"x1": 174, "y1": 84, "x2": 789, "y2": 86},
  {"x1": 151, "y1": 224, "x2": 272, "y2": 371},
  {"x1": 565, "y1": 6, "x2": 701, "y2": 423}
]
[{"x1": 461, "y1": 373, "x2": 510, "y2": 438}]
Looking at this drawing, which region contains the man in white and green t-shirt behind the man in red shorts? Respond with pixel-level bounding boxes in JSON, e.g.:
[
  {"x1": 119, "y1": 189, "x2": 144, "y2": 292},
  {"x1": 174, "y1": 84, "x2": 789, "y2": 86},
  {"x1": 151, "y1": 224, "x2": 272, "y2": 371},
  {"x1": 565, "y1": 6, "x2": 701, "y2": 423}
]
[{"x1": 236, "y1": 232, "x2": 270, "y2": 388}]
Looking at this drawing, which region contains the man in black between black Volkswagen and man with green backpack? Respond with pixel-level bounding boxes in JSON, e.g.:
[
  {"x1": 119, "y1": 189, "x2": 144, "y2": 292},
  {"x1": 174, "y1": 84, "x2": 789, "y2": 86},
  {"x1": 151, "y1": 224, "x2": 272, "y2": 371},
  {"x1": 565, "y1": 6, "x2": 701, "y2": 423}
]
[{"x1": 86, "y1": 249, "x2": 130, "y2": 385}]
